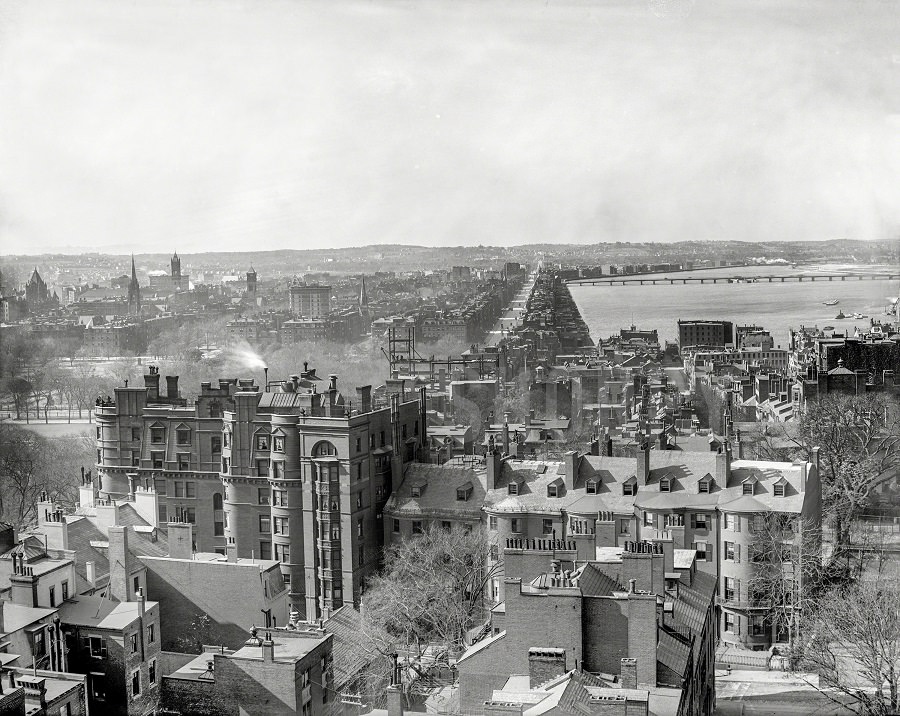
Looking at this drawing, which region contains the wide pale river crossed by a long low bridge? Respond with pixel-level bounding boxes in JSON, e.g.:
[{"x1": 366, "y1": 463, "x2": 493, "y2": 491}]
[{"x1": 569, "y1": 265, "x2": 900, "y2": 348}]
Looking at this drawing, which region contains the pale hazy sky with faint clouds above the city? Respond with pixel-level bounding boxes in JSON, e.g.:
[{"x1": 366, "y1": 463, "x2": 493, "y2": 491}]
[{"x1": 0, "y1": 0, "x2": 900, "y2": 254}]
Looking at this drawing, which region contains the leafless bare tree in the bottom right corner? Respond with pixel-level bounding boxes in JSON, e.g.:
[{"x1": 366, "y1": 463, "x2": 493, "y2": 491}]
[{"x1": 802, "y1": 580, "x2": 900, "y2": 716}]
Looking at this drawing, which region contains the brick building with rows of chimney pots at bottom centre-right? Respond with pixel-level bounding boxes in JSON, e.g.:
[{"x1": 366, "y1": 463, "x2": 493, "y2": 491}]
[{"x1": 457, "y1": 538, "x2": 716, "y2": 716}]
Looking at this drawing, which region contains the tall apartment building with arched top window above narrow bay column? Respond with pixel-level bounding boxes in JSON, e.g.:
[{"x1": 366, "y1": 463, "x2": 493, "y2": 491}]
[{"x1": 221, "y1": 365, "x2": 426, "y2": 619}]
